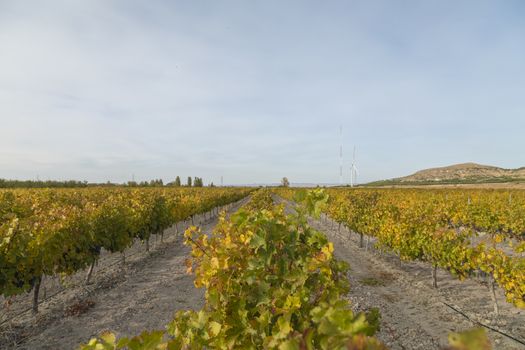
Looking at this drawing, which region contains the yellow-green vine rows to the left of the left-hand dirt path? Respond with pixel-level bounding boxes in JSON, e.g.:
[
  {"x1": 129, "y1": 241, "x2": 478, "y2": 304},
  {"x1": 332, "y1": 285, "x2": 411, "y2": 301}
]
[{"x1": 0, "y1": 189, "x2": 250, "y2": 313}]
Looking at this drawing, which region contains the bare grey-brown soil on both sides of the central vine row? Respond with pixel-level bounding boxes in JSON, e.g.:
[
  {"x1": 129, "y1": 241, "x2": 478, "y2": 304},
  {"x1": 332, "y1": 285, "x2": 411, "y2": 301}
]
[{"x1": 0, "y1": 197, "x2": 525, "y2": 350}]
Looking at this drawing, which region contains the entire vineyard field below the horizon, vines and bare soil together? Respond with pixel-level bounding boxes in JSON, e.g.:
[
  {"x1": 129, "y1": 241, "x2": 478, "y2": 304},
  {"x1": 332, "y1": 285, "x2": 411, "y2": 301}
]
[{"x1": 0, "y1": 188, "x2": 525, "y2": 349}]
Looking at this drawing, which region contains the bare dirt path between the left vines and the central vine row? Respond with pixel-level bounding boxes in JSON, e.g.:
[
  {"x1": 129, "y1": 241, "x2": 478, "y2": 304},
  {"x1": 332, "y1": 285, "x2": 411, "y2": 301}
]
[{"x1": 0, "y1": 201, "x2": 248, "y2": 350}]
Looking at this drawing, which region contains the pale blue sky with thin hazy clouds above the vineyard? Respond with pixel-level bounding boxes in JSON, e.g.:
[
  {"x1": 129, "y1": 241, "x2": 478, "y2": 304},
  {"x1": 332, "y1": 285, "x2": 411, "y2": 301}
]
[{"x1": 0, "y1": 0, "x2": 525, "y2": 184}]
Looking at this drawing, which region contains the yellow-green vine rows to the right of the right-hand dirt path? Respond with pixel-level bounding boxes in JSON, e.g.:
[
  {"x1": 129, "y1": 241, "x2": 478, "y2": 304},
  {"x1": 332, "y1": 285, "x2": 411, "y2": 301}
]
[{"x1": 279, "y1": 189, "x2": 525, "y2": 313}]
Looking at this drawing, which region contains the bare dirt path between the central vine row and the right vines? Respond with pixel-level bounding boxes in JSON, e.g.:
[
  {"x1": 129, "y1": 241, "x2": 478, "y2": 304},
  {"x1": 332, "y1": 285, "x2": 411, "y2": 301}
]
[{"x1": 294, "y1": 206, "x2": 525, "y2": 350}]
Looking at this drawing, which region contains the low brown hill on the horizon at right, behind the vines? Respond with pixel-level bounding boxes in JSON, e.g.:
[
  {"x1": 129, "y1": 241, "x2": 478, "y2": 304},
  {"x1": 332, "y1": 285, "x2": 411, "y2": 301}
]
[{"x1": 367, "y1": 163, "x2": 525, "y2": 186}]
